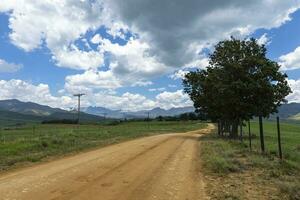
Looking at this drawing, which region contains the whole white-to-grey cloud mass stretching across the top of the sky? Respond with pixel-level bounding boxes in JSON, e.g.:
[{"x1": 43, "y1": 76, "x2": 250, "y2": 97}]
[{"x1": 0, "y1": 0, "x2": 300, "y2": 86}]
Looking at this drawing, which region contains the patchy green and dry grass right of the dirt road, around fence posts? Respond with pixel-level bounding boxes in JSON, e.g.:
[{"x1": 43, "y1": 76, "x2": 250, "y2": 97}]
[{"x1": 201, "y1": 122, "x2": 300, "y2": 200}]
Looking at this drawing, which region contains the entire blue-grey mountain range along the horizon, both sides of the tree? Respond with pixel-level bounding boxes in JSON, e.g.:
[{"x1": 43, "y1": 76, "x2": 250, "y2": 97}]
[{"x1": 0, "y1": 99, "x2": 300, "y2": 124}]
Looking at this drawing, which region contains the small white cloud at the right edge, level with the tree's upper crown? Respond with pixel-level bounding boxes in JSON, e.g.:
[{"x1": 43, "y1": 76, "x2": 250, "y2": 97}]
[{"x1": 279, "y1": 47, "x2": 300, "y2": 70}]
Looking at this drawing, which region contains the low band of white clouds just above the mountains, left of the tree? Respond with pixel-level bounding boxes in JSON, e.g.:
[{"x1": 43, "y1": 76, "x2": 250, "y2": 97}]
[{"x1": 0, "y1": 79, "x2": 192, "y2": 111}]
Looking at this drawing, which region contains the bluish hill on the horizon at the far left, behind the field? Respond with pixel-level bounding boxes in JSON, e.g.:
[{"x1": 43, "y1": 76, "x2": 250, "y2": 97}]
[{"x1": 0, "y1": 99, "x2": 67, "y2": 116}]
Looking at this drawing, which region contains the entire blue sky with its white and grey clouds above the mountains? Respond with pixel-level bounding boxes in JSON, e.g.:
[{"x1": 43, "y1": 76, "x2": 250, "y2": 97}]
[{"x1": 0, "y1": 0, "x2": 300, "y2": 111}]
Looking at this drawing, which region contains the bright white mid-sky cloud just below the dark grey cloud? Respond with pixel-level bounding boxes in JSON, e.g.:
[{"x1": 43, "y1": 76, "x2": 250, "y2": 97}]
[{"x1": 66, "y1": 36, "x2": 170, "y2": 90}]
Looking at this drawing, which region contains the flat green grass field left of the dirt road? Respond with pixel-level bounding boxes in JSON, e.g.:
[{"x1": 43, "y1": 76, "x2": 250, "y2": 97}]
[{"x1": 0, "y1": 121, "x2": 205, "y2": 171}]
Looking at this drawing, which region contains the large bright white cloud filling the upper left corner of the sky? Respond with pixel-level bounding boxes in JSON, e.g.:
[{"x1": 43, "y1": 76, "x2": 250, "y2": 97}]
[{"x1": 0, "y1": 0, "x2": 110, "y2": 70}]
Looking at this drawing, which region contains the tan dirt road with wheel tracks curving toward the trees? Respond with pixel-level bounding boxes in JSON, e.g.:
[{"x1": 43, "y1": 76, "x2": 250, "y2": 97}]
[{"x1": 0, "y1": 125, "x2": 213, "y2": 200}]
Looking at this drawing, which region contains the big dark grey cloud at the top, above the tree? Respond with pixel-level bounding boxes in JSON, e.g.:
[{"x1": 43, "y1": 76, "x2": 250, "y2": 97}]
[{"x1": 106, "y1": 0, "x2": 300, "y2": 66}]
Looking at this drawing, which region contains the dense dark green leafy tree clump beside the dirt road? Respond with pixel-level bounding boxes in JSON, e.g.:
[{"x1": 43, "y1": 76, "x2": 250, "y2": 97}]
[{"x1": 183, "y1": 38, "x2": 291, "y2": 138}]
